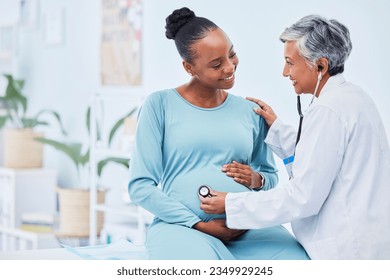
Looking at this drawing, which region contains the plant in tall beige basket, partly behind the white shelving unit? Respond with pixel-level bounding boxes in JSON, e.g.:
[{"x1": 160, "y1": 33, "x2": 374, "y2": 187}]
[{"x1": 37, "y1": 108, "x2": 136, "y2": 237}]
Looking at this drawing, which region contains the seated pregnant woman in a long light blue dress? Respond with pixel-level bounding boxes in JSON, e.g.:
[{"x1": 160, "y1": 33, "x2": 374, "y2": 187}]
[{"x1": 129, "y1": 8, "x2": 308, "y2": 260}]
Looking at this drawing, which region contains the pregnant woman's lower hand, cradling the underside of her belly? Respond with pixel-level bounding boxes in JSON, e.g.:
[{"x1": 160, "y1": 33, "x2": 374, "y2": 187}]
[{"x1": 194, "y1": 219, "x2": 245, "y2": 242}]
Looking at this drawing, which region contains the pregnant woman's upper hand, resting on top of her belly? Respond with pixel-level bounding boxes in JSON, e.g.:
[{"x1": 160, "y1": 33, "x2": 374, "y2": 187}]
[{"x1": 222, "y1": 161, "x2": 262, "y2": 188}]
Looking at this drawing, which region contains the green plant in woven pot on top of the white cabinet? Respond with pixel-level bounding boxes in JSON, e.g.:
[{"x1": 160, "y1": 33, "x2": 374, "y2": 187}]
[{"x1": 0, "y1": 74, "x2": 66, "y2": 168}]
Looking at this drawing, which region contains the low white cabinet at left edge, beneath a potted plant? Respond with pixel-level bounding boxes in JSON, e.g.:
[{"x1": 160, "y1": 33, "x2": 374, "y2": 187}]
[{"x1": 0, "y1": 168, "x2": 57, "y2": 251}]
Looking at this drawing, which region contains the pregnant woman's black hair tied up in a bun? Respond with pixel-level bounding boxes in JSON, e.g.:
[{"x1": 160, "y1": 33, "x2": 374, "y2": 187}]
[{"x1": 165, "y1": 7, "x2": 218, "y2": 63}]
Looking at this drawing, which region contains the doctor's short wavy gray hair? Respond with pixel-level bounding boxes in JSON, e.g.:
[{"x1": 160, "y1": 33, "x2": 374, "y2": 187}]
[{"x1": 279, "y1": 15, "x2": 352, "y2": 76}]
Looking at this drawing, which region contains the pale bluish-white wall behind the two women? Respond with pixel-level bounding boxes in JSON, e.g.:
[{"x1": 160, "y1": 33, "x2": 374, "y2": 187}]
[{"x1": 6, "y1": 0, "x2": 390, "y2": 185}]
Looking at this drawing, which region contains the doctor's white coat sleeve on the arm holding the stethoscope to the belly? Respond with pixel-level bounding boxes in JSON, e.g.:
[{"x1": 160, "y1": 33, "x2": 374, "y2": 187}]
[{"x1": 225, "y1": 106, "x2": 348, "y2": 229}]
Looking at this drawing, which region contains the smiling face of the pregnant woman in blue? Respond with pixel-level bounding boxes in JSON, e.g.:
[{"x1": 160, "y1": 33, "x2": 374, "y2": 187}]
[{"x1": 184, "y1": 28, "x2": 239, "y2": 89}]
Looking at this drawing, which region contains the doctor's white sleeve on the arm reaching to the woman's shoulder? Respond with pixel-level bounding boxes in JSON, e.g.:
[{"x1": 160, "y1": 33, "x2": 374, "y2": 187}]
[{"x1": 265, "y1": 118, "x2": 297, "y2": 177}]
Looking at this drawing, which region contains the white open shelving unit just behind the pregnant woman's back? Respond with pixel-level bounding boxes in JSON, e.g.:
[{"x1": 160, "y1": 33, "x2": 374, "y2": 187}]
[{"x1": 89, "y1": 91, "x2": 151, "y2": 245}]
